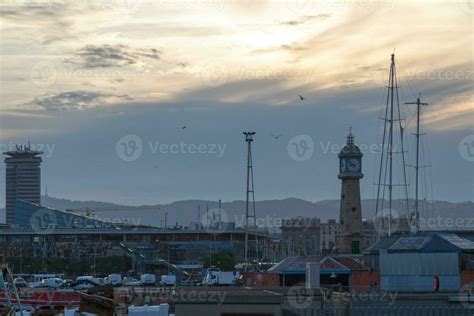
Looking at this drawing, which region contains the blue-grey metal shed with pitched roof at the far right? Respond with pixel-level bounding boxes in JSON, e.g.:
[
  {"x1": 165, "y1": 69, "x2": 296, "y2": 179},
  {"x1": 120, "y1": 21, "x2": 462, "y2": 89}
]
[{"x1": 364, "y1": 231, "x2": 474, "y2": 292}]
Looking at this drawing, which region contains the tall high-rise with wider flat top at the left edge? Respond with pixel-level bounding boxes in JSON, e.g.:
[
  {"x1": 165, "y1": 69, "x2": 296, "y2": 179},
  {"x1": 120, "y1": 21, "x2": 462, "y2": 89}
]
[{"x1": 3, "y1": 145, "x2": 43, "y2": 224}]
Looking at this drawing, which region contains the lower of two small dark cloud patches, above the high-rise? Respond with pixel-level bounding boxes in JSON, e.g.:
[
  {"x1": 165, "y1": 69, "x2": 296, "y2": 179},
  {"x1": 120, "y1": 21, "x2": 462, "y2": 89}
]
[{"x1": 25, "y1": 90, "x2": 131, "y2": 111}]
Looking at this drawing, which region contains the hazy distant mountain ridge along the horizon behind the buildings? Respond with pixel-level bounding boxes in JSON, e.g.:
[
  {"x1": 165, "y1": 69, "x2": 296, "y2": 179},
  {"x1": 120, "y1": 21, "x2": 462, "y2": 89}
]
[{"x1": 0, "y1": 196, "x2": 474, "y2": 229}]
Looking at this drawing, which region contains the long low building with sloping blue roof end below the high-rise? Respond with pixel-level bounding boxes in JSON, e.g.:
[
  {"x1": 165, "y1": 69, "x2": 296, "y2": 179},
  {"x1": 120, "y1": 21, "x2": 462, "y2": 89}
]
[{"x1": 0, "y1": 201, "x2": 278, "y2": 267}]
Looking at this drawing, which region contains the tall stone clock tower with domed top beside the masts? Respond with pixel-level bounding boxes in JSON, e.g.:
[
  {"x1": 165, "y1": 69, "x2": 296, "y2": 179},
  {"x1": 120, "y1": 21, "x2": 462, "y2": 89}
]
[{"x1": 336, "y1": 131, "x2": 366, "y2": 254}]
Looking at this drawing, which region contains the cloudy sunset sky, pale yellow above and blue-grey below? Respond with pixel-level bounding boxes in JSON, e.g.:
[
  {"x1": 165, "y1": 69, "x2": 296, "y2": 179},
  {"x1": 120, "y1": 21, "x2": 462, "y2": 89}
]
[{"x1": 0, "y1": 0, "x2": 474, "y2": 205}]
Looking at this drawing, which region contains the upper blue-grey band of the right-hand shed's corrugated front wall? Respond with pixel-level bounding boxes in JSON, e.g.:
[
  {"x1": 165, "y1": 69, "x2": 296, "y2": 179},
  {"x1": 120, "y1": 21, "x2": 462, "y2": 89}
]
[{"x1": 380, "y1": 253, "x2": 459, "y2": 276}]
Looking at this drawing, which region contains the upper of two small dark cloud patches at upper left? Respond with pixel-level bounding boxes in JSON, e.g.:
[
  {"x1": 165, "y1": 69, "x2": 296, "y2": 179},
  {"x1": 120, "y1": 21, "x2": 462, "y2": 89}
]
[{"x1": 65, "y1": 44, "x2": 161, "y2": 68}]
